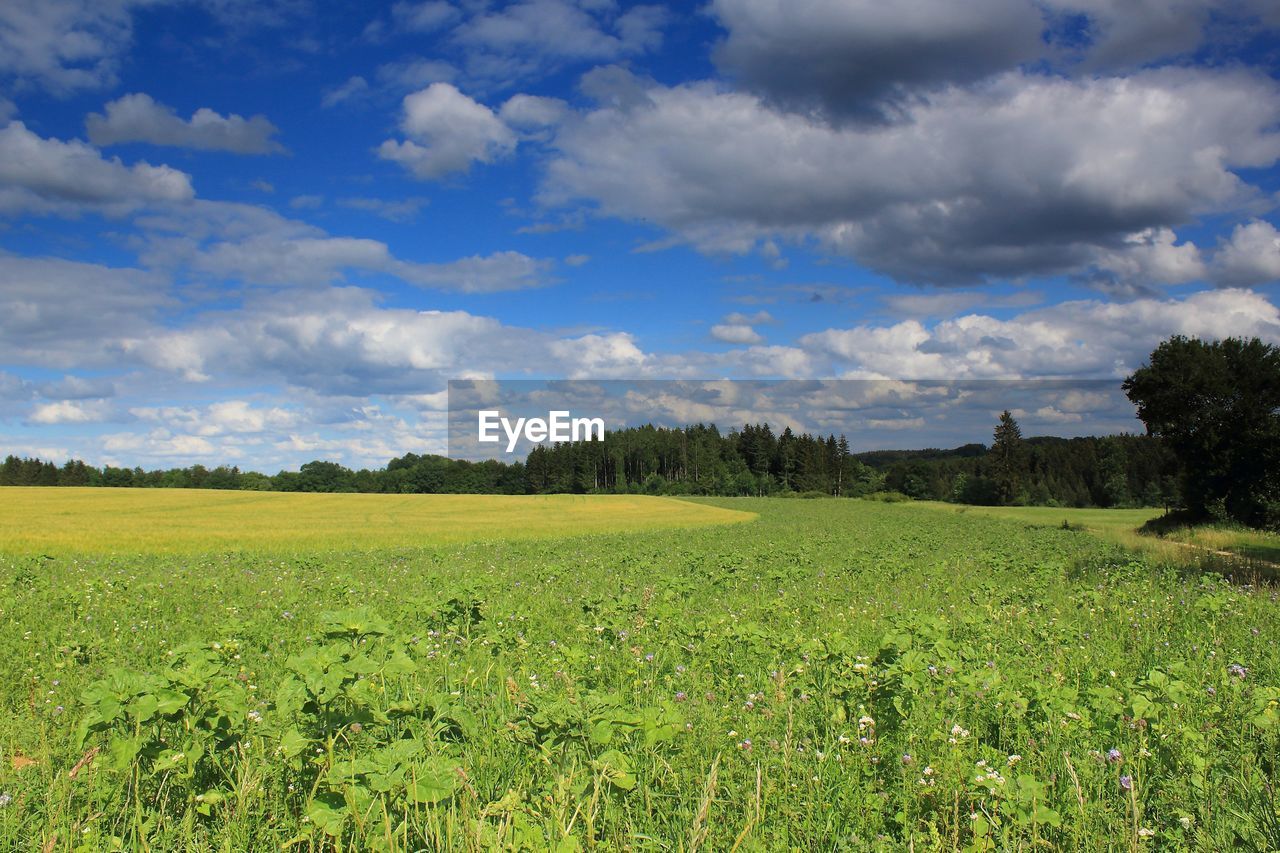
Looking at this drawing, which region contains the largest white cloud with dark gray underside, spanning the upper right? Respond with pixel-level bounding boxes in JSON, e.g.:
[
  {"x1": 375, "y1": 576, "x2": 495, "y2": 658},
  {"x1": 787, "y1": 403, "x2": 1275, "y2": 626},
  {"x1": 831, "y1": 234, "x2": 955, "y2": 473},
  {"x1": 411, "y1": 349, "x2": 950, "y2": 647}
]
[{"x1": 543, "y1": 69, "x2": 1280, "y2": 283}]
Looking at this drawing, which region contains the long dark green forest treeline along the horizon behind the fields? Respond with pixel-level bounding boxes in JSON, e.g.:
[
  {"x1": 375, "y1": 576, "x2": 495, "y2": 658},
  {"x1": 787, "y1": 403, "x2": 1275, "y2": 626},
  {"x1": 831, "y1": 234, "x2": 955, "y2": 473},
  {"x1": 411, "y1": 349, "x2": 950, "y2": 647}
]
[{"x1": 0, "y1": 414, "x2": 1178, "y2": 507}]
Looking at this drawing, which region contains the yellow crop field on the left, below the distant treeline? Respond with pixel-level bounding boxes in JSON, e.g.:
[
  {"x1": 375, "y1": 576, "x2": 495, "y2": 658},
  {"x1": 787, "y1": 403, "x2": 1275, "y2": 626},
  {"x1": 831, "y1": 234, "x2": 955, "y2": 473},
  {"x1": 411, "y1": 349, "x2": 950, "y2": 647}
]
[{"x1": 0, "y1": 487, "x2": 756, "y2": 555}]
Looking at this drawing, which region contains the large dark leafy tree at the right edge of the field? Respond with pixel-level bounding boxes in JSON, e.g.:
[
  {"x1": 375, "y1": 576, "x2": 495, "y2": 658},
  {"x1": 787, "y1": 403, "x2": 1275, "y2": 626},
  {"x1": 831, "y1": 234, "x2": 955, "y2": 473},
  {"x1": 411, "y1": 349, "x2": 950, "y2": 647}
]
[{"x1": 1124, "y1": 336, "x2": 1280, "y2": 528}]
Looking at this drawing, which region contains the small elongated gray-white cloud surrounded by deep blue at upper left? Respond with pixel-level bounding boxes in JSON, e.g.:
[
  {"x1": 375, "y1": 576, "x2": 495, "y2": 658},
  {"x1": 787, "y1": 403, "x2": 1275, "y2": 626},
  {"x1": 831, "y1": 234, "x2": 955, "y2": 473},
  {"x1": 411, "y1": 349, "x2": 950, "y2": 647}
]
[{"x1": 84, "y1": 93, "x2": 284, "y2": 154}]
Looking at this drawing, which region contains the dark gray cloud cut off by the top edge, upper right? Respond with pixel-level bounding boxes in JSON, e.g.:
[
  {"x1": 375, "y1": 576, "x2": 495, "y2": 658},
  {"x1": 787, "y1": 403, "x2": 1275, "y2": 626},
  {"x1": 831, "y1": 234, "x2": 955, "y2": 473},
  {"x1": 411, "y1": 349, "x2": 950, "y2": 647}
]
[{"x1": 710, "y1": 0, "x2": 1280, "y2": 122}]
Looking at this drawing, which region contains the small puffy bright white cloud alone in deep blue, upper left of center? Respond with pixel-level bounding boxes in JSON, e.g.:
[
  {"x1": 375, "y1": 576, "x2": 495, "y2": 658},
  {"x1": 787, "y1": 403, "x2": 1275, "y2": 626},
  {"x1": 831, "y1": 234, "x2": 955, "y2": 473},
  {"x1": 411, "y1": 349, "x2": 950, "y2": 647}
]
[{"x1": 378, "y1": 83, "x2": 516, "y2": 179}]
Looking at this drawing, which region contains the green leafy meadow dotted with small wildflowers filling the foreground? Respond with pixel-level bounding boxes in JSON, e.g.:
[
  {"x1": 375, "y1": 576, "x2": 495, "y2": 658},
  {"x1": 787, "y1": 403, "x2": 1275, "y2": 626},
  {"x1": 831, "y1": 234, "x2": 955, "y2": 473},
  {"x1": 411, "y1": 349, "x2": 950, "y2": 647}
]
[{"x1": 0, "y1": 489, "x2": 1280, "y2": 850}]
